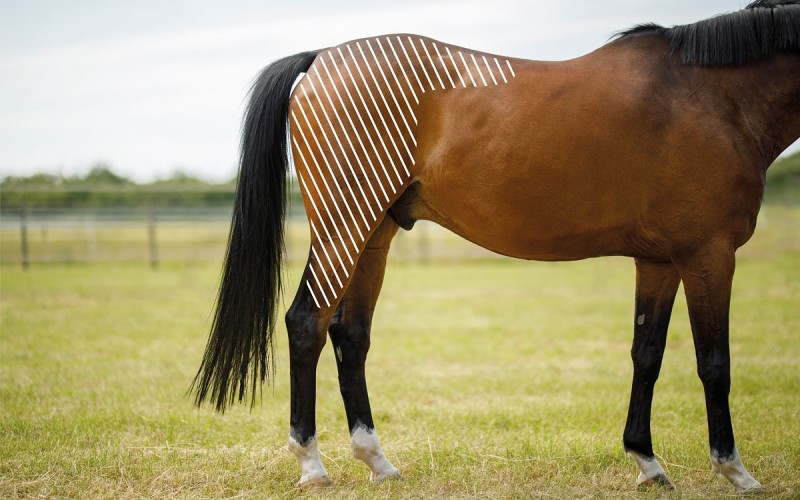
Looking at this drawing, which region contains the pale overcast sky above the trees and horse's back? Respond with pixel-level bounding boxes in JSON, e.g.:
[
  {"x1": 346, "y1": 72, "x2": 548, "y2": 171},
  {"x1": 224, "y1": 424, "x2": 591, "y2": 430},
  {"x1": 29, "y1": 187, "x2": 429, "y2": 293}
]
[{"x1": 0, "y1": 0, "x2": 798, "y2": 181}]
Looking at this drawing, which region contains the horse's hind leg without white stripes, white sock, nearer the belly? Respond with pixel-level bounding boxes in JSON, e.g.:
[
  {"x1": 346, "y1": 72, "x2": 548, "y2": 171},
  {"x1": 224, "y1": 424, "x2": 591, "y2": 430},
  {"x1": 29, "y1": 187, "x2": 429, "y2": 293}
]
[{"x1": 329, "y1": 217, "x2": 400, "y2": 481}]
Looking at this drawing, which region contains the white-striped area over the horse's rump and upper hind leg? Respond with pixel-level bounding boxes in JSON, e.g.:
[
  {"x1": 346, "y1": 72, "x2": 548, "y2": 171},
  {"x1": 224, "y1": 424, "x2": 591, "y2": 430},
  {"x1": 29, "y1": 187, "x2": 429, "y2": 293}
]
[{"x1": 289, "y1": 35, "x2": 516, "y2": 308}]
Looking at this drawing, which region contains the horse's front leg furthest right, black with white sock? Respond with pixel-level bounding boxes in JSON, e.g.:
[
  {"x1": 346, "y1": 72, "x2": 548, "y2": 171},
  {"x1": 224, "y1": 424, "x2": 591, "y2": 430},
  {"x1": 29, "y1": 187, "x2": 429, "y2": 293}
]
[{"x1": 677, "y1": 243, "x2": 761, "y2": 492}]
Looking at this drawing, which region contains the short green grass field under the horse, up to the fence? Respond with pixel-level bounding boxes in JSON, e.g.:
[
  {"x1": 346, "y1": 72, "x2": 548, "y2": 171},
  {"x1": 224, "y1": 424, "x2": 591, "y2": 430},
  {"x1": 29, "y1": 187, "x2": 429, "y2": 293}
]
[{"x1": 0, "y1": 208, "x2": 800, "y2": 498}]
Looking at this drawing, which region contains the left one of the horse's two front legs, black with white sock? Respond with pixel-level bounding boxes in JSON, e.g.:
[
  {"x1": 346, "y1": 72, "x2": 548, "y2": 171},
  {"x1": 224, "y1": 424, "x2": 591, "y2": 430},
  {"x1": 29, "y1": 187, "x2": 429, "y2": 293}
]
[{"x1": 623, "y1": 259, "x2": 680, "y2": 488}]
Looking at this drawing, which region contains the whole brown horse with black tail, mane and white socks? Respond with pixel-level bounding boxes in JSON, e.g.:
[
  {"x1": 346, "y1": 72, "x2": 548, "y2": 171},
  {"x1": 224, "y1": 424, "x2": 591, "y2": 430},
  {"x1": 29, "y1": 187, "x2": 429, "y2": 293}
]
[{"x1": 193, "y1": 0, "x2": 800, "y2": 490}]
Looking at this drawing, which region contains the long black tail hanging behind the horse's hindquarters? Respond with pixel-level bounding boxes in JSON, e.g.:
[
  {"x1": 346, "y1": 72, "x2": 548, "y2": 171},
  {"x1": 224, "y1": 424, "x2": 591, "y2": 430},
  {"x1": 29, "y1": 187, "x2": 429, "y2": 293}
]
[{"x1": 189, "y1": 52, "x2": 318, "y2": 412}]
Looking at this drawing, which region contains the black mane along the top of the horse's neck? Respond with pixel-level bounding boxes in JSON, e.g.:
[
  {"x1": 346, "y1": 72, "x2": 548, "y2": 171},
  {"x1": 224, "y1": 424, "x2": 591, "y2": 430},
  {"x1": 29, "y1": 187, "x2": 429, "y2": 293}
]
[{"x1": 615, "y1": 0, "x2": 800, "y2": 66}]
